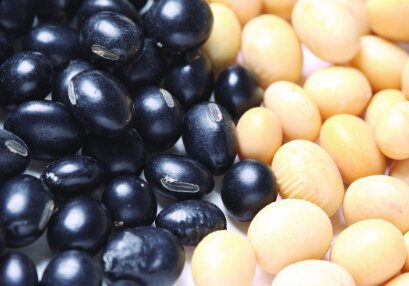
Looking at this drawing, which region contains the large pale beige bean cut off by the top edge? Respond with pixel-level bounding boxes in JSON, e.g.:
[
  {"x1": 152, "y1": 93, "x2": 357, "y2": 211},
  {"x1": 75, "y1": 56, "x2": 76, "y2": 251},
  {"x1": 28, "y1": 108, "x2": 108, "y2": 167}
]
[{"x1": 291, "y1": 0, "x2": 361, "y2": 63}]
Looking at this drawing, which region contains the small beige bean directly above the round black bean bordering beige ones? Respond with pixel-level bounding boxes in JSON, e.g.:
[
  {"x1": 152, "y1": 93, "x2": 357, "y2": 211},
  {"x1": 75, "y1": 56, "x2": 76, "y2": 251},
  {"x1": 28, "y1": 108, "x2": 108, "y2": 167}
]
[{"x1": 237, "y1": 107, "x2": 283, "y2": 164}]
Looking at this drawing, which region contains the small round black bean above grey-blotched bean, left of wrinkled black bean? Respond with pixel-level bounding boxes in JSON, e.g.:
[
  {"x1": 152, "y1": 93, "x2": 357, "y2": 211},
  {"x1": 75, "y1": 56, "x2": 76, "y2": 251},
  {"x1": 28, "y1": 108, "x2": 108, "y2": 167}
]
[{"x1": 102, "y1": 176, "x2": 157, "y2": 228}]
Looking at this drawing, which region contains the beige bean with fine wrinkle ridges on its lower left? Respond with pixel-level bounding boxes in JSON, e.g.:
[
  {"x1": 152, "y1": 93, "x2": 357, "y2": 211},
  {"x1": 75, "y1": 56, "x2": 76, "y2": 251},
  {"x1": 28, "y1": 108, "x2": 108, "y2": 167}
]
[{"x1": 271, "y1": 140, "x2": 344, "y2": 217}]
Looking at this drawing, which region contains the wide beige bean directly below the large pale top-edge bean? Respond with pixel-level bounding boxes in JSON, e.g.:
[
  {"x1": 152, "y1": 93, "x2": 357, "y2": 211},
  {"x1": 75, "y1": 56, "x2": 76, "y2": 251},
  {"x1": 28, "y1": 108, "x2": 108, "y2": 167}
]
[{"x1": 304, "y1": 67, "x2": 372, "y2": 119}]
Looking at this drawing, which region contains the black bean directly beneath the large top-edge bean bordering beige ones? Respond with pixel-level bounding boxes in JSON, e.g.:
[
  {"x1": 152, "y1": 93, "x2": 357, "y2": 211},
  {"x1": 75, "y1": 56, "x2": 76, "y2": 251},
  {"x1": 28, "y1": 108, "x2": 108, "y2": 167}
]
[{"x1": 163, "y1": 53, "x2": 214, "y2": 110}]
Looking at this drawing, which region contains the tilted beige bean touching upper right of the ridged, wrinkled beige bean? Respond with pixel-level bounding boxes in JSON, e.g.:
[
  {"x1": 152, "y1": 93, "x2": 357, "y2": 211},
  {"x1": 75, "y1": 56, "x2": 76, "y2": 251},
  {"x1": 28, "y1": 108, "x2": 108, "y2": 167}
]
[{"x1": 319, "y1": 114, "x2": 386, "y2": 185}]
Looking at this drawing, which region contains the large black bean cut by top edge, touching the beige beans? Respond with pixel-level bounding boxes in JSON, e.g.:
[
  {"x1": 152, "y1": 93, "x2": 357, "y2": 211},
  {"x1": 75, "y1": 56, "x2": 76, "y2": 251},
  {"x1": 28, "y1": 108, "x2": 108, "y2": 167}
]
[{"x1": 144, "y1": 0, "x2": 213, "y2": 53}]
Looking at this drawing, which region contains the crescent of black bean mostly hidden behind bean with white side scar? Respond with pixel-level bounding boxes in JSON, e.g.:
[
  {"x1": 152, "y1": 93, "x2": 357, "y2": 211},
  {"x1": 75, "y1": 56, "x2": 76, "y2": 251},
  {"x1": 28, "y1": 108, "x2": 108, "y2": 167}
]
[{"x1": 51, "y1": 60, "x2": 94, "y2": 106}]
